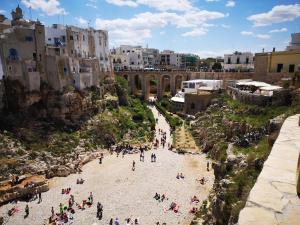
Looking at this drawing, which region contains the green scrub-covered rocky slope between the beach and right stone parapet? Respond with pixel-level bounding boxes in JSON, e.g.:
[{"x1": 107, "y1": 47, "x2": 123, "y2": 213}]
[{"x1": 191, "y1": 94, "x2": 300, "y2": 225}]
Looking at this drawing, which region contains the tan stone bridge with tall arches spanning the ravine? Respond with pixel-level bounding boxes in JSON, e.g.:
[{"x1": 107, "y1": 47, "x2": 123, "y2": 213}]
[{"x1": 115, "y1": 71, "x2": 192, "y2": 100}]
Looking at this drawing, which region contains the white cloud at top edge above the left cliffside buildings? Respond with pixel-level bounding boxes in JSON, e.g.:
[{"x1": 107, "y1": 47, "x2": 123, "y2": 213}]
[{"x1": 22, "y1": 0, "x2": 68, "y2": 16}]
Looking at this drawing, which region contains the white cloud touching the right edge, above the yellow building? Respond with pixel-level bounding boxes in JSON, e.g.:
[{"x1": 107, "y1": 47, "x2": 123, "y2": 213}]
[{"x1": 247, "y1": 4, "x2": 300, "y2": 27}]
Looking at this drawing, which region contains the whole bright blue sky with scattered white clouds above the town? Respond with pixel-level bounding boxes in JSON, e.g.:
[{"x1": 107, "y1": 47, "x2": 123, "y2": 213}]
[{"x1": 0, "y1": 0, "x2": 300, "y2": 57}]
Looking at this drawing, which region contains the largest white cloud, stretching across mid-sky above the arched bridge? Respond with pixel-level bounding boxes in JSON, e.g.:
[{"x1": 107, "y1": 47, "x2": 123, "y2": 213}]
[{"x1": 95, "y1": 10, "x2": 226, "y2": 44}]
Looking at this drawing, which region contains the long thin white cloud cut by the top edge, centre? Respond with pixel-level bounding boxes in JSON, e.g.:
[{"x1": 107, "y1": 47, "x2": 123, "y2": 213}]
[{"x1": 106, "y1": 0, "x2": 195, "y2": 11}]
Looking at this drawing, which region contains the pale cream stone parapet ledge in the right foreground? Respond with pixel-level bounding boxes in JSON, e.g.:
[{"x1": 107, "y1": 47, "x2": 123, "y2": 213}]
[{"x1": 238, "y1": 114, "x2": 300, "y2": 225}]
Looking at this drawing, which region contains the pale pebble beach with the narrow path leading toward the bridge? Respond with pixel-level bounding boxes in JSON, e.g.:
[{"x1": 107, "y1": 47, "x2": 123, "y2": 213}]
[{"x1": 0, "y1": 108, "x2": 214, "y2": 225}]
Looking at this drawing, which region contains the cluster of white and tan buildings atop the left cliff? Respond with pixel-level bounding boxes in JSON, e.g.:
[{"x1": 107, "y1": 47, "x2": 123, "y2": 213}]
[{"x1": 0, "y1": 7, "x2": 112, "y2": 92}]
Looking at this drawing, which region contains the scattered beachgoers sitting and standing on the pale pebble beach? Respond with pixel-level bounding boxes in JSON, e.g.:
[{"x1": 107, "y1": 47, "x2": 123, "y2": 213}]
[{"x1": 1, "y1": 108, "x2": 210, "y2": 225}]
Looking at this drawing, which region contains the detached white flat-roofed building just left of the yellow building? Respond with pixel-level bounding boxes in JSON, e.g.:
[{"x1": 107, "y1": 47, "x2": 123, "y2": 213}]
[{"x1": 224, "y1": 52, "x2": 254, "y2": 71}]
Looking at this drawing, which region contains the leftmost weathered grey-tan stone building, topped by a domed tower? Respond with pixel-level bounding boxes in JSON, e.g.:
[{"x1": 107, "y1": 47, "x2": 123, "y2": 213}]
[{"x1": 0, "y1": 7, "x2": 46, "y2": 92}]
